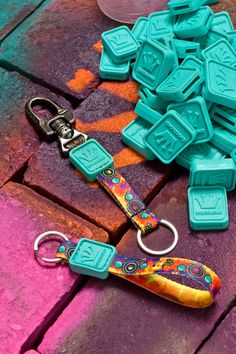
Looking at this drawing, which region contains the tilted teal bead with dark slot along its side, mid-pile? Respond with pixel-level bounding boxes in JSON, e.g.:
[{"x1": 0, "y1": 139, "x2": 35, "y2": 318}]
[{"x1": 157, "y1": 66, "x2": 203, "y2": 102}]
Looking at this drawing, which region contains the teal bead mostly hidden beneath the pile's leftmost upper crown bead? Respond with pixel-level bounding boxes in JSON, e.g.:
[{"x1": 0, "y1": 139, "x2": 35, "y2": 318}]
[{"x1": 100, "y1": 49, "x2": 130, "y2": 81}]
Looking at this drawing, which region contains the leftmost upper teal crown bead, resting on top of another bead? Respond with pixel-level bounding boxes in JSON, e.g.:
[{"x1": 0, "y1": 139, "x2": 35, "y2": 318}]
[{"x1": 102, "y1": 26, "x2": 139, "y2": 64}]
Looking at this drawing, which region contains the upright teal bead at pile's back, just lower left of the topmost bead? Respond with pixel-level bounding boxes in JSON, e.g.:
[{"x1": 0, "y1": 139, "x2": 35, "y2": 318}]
[{"x1": 148, "y1": 11, "x2": 174, "y2": 40}]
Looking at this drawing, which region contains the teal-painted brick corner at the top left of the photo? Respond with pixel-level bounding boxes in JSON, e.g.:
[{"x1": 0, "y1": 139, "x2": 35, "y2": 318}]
[{"x1": 0, "y1": 0, "x2": 42, "y2": 41}]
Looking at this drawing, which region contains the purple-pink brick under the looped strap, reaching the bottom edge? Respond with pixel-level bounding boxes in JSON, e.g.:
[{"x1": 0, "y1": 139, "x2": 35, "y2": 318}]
[{"x1": 39, "y1": 176, "x2": 236, "y2": 354}]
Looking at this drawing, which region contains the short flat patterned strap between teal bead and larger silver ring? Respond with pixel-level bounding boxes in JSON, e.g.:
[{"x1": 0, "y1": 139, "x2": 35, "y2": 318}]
[{"x1": 97, "y1": 168, "x2": 160, "y2": 234}]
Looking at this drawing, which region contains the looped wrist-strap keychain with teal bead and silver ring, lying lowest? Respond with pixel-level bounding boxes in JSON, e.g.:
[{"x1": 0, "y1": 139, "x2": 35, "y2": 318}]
[{"x1": 34, "y1": 231, "x2": 221, "y2": 308}]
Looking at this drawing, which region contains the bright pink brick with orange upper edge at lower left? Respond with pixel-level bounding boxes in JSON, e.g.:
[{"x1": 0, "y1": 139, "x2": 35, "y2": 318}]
[{"x1": 0, "y1": 182, "x2": 108, "y2": 354}]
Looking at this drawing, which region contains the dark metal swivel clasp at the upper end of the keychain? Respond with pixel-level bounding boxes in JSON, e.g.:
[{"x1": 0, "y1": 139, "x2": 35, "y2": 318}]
[{"x1": 25, "y1": 97, "x2": 88, "y2": 153}]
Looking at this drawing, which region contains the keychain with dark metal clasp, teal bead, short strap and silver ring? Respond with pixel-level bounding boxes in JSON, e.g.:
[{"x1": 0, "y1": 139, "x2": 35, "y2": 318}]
[{"x1": 26, "y1": 97, "x2": 178, "y2": 256}]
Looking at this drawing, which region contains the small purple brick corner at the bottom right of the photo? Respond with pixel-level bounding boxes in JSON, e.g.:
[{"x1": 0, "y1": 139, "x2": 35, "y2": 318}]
[{"x1": 199, "y1": 307, "x2": 236, "y2": 354}]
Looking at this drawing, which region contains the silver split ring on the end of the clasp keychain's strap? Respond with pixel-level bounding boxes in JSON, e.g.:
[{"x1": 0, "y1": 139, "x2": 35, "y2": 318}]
[{"x1": 137, "y1": 219, "x2": 178, "y2": 256}]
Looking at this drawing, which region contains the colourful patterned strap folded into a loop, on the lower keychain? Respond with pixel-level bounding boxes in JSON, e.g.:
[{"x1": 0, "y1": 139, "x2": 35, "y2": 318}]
[{"x1": 56, "y1": 241, "x2": 221, "y2": 308}]
